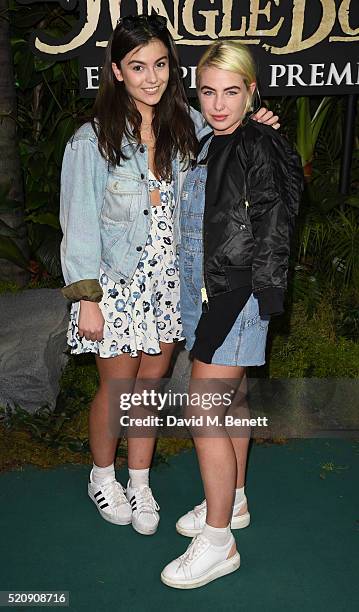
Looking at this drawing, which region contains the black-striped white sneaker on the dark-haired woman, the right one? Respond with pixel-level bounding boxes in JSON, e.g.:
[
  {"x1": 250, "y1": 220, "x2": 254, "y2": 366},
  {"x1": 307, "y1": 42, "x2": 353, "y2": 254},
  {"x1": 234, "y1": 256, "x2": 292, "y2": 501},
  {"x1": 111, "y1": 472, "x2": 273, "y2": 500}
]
[{"x1": 126, "y1": 481, "x2": 160, "y2": 535}]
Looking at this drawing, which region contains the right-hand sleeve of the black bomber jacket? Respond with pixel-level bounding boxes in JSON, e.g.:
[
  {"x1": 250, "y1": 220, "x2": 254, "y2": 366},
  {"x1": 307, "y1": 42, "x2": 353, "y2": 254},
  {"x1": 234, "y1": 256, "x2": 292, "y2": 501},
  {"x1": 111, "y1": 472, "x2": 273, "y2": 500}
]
[{"x1": 246, "y1": 134, "x2": 295, "y2": 316}]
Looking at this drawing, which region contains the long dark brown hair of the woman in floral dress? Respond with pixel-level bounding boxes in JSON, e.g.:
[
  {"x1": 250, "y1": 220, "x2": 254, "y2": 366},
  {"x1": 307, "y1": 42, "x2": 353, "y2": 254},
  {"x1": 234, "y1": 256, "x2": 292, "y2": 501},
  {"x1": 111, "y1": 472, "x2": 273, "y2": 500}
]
[{"x1": 92, "y1": 15, "x2": 197, "y2": 178}]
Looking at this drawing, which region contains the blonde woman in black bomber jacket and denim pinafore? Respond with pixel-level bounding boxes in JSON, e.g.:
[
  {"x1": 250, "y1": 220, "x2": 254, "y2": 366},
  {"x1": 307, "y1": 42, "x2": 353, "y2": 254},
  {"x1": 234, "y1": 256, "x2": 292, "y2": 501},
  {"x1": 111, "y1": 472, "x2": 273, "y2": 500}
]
[{"x1": 161, "y1": 41, "x2": 302, "y2": 589}]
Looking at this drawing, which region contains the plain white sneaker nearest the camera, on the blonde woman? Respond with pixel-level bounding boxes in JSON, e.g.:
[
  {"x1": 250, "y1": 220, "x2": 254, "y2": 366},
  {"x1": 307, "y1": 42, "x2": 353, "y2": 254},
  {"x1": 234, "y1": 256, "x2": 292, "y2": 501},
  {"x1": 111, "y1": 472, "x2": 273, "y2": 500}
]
[{"x1": 161, "y1": 534, "x2": 240, "y2": 589}]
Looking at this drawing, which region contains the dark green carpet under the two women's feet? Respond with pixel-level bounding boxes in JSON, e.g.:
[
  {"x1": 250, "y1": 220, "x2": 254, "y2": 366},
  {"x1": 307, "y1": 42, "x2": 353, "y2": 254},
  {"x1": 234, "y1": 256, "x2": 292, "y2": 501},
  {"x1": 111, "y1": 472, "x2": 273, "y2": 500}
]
[{"x1": 0, "y1": 440, "x2": 359, "y2": 612}]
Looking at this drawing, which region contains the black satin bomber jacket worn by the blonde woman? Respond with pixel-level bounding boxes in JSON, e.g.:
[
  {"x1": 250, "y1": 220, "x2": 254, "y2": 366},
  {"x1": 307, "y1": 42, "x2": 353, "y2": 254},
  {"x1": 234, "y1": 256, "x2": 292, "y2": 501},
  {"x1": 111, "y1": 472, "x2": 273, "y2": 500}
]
[{"x1": 201, "y1": 119, "x2": 304, "y2": 316}]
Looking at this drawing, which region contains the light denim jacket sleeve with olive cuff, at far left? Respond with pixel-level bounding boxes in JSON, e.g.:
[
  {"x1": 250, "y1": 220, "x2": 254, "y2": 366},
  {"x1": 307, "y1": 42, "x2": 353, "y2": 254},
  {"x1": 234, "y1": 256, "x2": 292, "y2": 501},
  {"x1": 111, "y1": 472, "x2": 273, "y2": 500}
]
[{"x1": 60, "y1": 135, "x2": 107, "y2": 302}]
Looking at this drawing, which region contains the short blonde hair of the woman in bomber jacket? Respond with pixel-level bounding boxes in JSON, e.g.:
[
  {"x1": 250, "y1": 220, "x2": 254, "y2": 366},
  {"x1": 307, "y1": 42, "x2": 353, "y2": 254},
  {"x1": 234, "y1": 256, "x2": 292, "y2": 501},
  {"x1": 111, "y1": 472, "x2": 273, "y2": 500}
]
[{"x1": 196, "y1": 40, "x2": 257, "y2": 113}]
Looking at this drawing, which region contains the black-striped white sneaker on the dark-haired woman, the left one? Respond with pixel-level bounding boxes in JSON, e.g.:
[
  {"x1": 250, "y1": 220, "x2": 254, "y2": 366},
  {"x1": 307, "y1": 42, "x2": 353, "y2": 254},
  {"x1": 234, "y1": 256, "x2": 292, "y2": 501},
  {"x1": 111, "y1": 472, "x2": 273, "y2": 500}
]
[{"x1": 88, "y1": 470, "x2": 132, "y2": 525}]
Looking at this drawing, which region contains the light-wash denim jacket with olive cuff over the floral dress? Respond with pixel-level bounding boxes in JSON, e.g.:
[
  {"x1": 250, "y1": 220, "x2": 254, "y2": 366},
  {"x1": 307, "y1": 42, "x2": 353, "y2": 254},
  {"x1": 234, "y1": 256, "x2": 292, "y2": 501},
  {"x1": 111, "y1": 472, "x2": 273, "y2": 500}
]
[{"x1": 60, "y1": 108, "x2": 210, "y2": 302}]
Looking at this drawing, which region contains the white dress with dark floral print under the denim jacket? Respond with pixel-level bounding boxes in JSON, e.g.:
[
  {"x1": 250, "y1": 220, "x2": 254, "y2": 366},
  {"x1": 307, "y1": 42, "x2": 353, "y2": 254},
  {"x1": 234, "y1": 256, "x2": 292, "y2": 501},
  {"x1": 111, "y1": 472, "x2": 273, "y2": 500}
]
[{"x1": 67, "y1": 171, "x2": 183, "y2": 357}]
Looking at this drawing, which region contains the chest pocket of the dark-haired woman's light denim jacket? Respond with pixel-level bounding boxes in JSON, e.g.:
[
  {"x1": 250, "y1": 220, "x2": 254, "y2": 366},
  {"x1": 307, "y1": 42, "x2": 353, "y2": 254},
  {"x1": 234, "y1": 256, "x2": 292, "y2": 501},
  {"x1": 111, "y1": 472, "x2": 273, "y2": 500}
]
[{"x1": 101, "y1": 172, "x2": 141, "y2": 224}]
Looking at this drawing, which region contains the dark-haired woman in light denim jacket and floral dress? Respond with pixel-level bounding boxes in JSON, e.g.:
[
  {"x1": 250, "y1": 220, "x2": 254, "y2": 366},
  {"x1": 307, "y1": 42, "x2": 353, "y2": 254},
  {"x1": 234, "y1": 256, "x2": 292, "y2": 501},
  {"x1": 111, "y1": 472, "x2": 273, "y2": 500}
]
[{"x1": 60, "y1": 15, "x2": 276, "y2": 535}]
